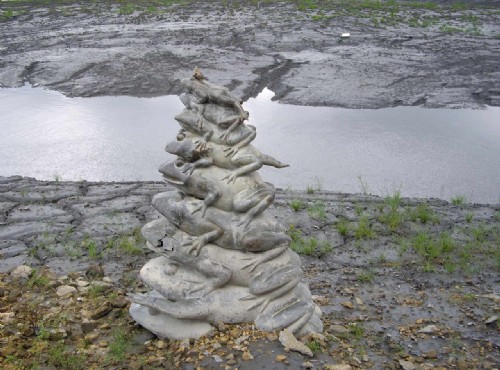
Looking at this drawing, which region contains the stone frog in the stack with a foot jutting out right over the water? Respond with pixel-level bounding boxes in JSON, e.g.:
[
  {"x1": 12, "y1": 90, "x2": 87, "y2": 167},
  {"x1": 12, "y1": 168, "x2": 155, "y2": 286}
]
[{"x1": 165, "y1": 130, "x2": 288, "y2": 183}]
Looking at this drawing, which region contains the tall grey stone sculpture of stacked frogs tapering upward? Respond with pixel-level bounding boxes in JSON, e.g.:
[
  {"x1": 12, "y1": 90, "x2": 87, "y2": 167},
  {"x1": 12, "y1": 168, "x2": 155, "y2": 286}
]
[{"x1": 130, "y1": 68, "x2": 323, "y2": 339}]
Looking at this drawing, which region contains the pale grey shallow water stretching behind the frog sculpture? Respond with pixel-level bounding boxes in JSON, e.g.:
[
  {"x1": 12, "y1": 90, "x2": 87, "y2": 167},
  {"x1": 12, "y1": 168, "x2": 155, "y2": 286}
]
[{"x1": 0, "y1": 86, "x2": 500, "y2": 203}]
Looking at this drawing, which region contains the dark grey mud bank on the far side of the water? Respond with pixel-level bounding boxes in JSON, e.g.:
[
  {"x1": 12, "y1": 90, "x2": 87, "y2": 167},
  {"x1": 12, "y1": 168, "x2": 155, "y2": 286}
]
[{"x1": 0, "y1": 1, "x2": 500, "y2": 108}]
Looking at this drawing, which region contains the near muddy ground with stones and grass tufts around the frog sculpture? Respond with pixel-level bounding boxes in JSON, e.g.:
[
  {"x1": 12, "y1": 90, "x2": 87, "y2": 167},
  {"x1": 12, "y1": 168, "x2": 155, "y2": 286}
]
[{"x1": 0, "y1": 177, "x2": 500, "y2": 369}]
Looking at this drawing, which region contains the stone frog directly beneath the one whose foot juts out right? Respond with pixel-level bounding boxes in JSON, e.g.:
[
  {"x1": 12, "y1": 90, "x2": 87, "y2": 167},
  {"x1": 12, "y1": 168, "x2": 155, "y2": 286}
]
[{"x1": 159, "y1": 158, "x2": 275, "y2": 228}]
